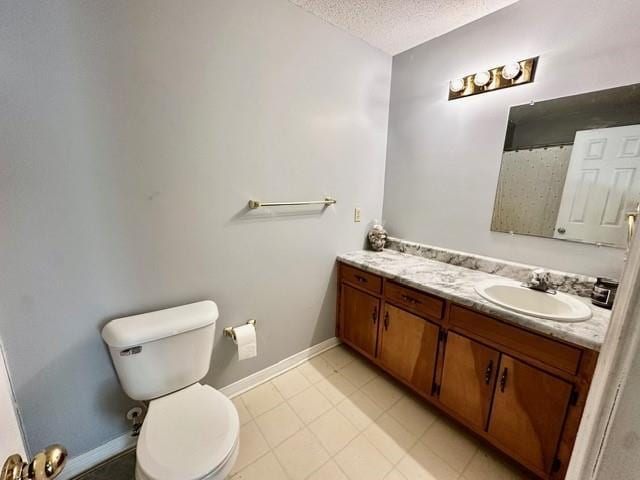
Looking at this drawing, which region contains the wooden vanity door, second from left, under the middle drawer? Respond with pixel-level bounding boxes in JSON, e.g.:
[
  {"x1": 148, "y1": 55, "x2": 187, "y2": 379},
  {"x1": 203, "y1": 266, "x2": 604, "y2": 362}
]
[{"x1": 378, "y1": 304, "x2": 440, "y2": 393}]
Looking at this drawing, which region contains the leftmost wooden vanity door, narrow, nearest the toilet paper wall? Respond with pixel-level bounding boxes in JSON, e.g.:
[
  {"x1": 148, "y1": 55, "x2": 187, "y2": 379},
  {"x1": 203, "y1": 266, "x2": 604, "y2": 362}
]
[{"x1": 340, "y1": 284, "x2": 380, "y2": 357}]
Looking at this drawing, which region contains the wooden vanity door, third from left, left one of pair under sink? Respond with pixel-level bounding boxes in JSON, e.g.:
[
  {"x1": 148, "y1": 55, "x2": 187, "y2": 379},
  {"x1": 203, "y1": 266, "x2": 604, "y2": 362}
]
[{"x1": 440, "y1": 332, "x2": 500, "y2": 430}]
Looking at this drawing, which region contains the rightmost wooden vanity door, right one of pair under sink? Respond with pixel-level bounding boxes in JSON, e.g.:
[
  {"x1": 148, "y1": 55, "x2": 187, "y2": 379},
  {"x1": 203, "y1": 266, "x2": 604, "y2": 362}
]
[{"x1": 489, "y1": 354, "x2": 572, "y2": 473}]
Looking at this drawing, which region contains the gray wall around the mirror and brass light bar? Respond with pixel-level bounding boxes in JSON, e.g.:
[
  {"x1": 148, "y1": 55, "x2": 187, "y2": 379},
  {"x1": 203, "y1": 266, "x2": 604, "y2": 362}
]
[{"x1": 383, "y1": 0, "x2": 640, "y2": 276}]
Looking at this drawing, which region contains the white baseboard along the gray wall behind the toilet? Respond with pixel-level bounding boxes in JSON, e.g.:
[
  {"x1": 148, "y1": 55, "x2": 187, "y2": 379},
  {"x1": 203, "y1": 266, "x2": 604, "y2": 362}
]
[{"x1": 58, "y1": 337, "x2": 340, "y2": 480}]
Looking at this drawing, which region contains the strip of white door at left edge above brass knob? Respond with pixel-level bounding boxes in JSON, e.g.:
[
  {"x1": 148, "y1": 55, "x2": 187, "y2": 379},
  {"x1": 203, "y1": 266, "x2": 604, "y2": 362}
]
[{"x1": 0, "y1": 342, "x2": 25, "y2": 464}]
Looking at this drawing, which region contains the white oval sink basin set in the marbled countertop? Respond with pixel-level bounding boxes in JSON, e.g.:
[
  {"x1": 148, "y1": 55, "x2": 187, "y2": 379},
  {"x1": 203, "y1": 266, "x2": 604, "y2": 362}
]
[{"x1": 475, "y1": 280, "x2": 591, "y2": 322}]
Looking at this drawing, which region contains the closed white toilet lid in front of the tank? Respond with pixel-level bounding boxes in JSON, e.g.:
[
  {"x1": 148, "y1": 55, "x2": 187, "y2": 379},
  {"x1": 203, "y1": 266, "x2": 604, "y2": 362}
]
[{"x1": 136, "y1": 383, "x2": 240, "y2": 480}]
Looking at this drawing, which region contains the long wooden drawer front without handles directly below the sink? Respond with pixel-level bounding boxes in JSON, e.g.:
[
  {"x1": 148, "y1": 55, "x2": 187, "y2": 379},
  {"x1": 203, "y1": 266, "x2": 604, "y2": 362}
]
[{"x1": 449, "y1": 305, "x2": 582, "y2": 375}]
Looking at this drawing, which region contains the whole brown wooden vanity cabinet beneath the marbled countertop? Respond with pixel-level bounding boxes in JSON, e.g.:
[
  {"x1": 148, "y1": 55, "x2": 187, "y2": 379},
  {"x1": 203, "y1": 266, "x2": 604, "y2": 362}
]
[{"x1": 336, "y1": 263, "x2": 598, "y2": 480}]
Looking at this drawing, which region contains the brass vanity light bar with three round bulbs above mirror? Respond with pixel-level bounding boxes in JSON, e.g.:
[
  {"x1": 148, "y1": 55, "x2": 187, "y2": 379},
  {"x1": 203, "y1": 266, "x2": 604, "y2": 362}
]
[{"x1": 449, "y1": 57, "x2": 538, "y2": 100}]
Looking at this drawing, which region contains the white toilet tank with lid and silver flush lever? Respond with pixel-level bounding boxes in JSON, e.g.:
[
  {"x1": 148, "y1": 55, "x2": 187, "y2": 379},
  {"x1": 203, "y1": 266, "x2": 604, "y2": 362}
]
[{"x1": 102, "y1": 300, "x2": 218, "y2": 400}]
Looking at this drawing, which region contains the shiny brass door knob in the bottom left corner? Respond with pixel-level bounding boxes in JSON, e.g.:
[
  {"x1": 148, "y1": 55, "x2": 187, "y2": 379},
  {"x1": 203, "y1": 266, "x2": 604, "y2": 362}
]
[{"x1": 0, "y1": 444, "x2": 67, "y2": 480}]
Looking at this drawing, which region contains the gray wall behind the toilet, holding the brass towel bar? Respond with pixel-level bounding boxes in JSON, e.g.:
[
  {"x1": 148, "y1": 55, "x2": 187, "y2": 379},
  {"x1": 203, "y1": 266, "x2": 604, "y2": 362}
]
[{"x1": 0, "y1": 0, "x2": 391, "y2": 456}]
